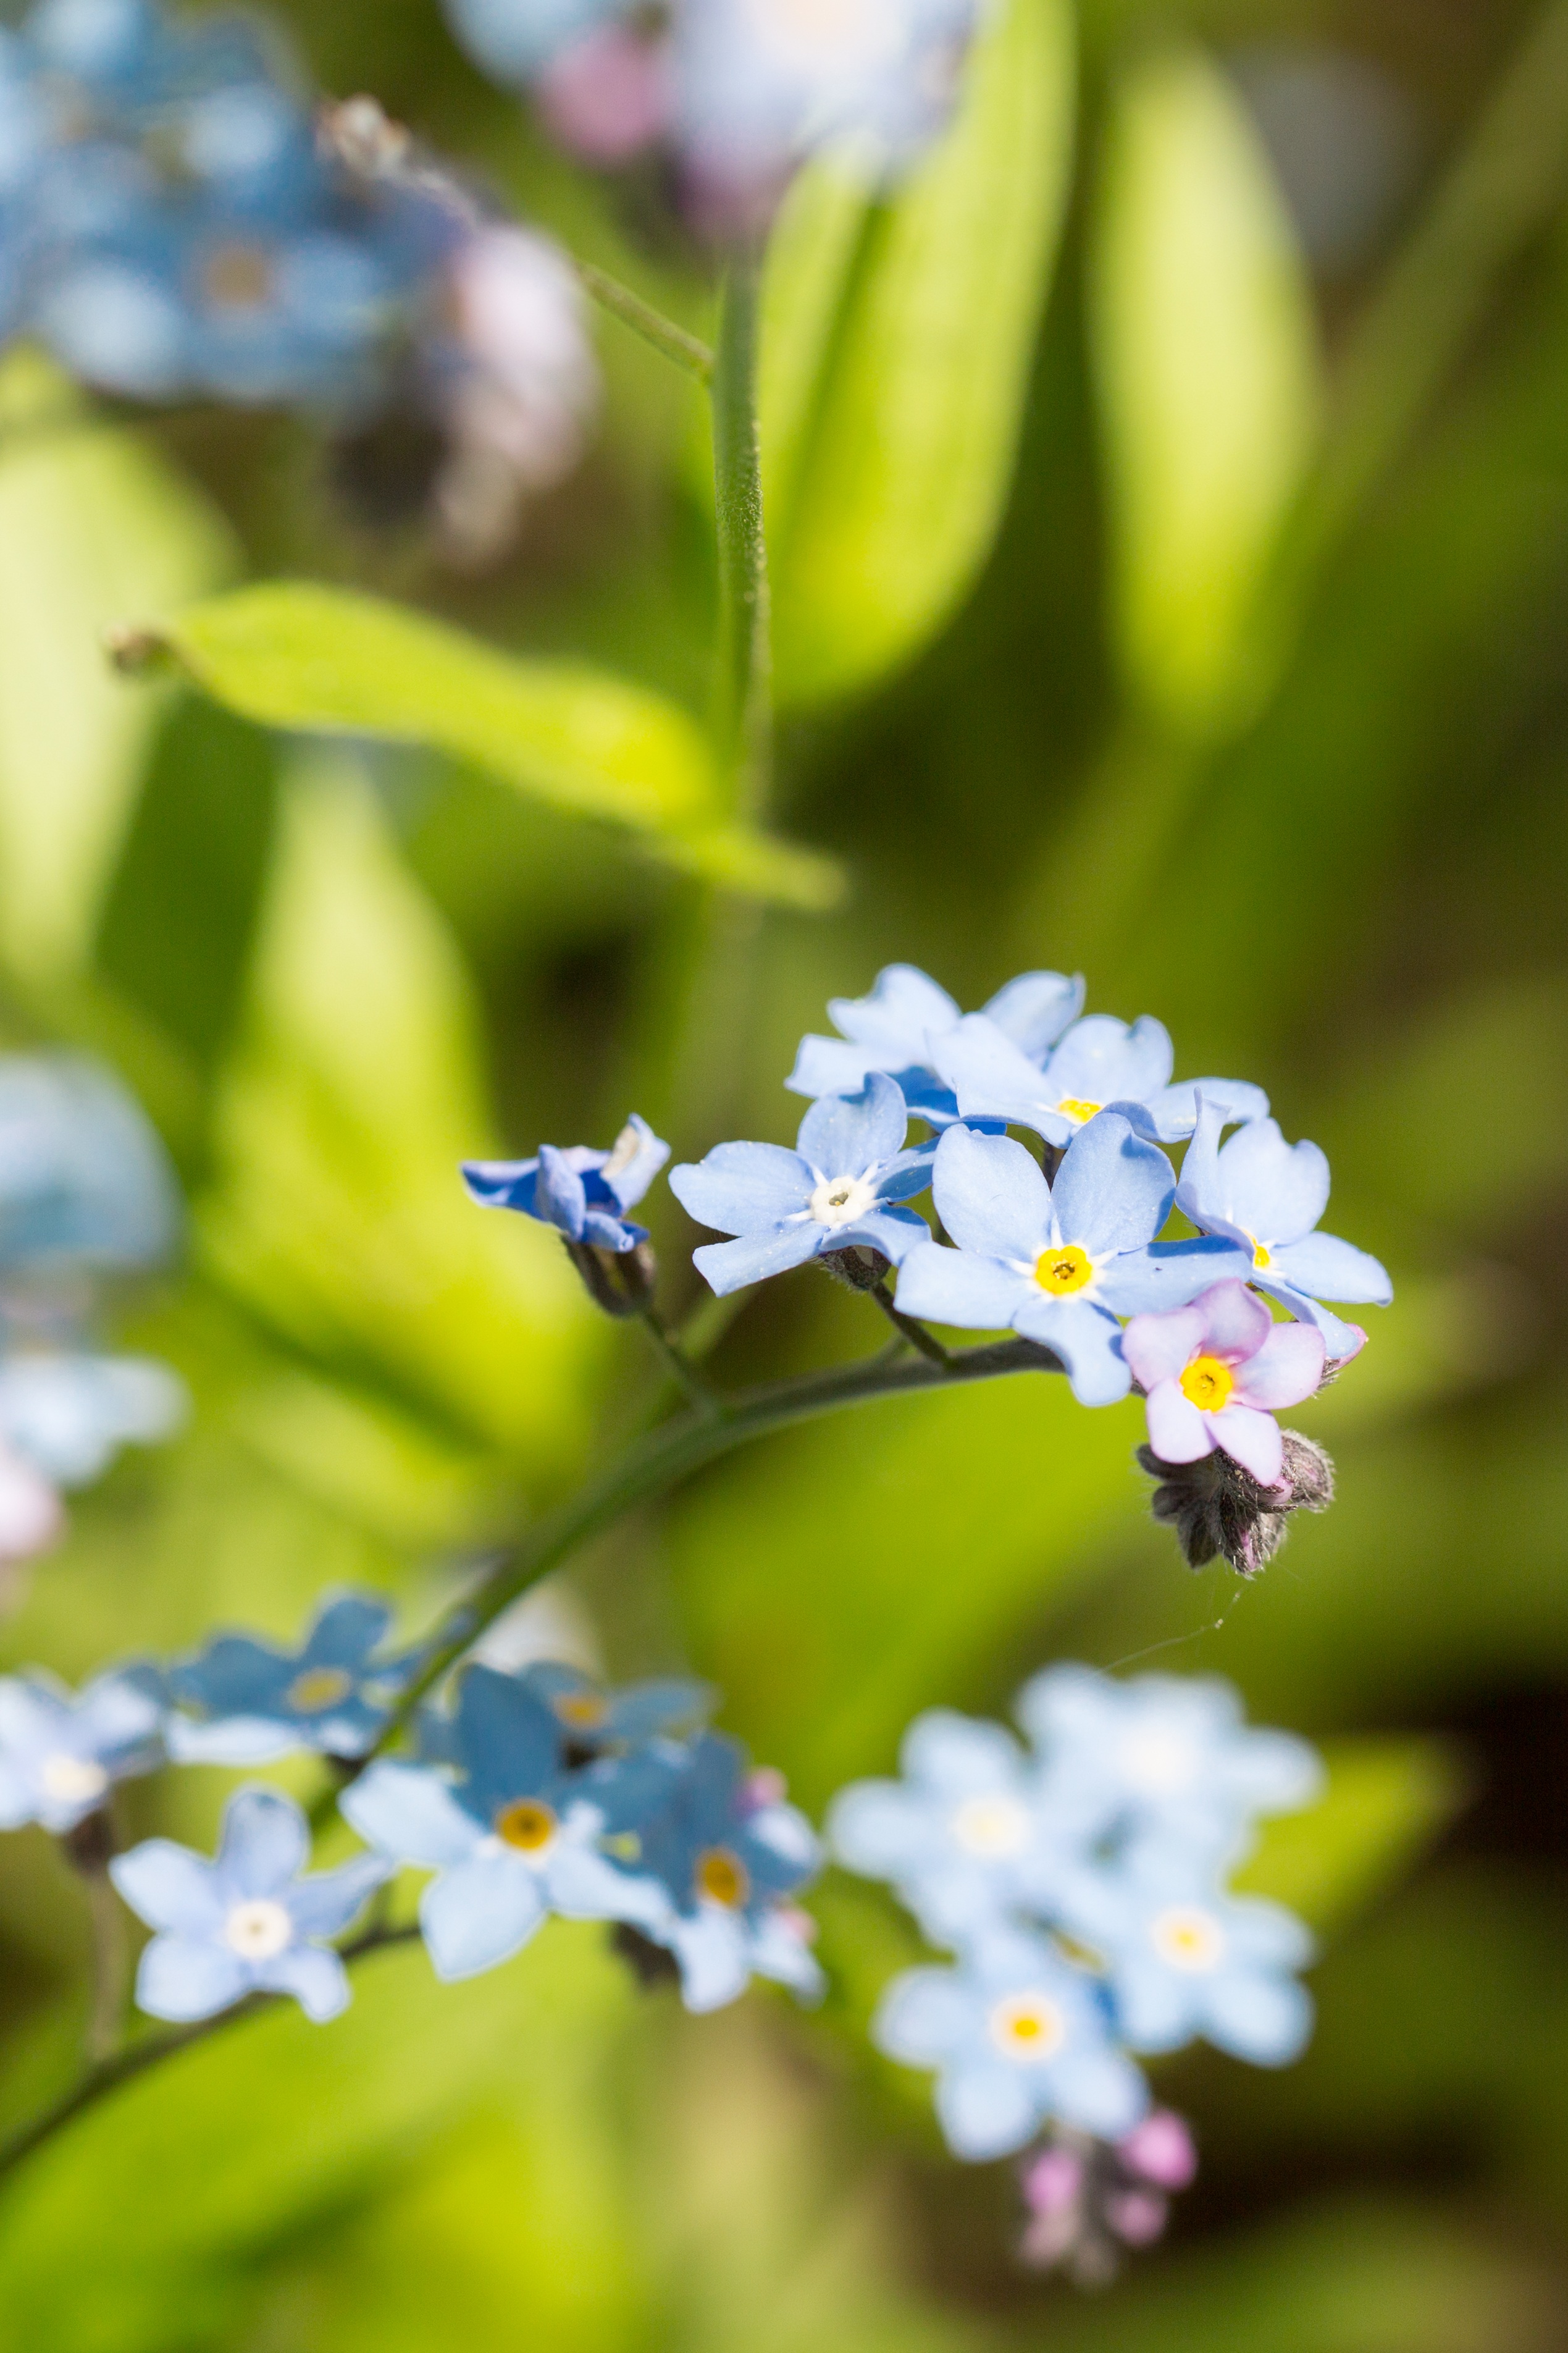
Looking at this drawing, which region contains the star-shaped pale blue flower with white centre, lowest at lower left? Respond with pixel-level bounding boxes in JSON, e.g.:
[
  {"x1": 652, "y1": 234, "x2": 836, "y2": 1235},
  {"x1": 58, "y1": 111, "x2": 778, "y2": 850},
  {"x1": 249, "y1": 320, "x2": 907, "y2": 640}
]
[{"x1": 108, "y1": 1788, "x2": 388, "y2": 2024}]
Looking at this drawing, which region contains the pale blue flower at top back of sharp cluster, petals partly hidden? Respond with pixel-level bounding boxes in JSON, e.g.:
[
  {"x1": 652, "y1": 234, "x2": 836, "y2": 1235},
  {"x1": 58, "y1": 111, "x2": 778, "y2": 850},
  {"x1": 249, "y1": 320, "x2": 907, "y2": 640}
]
[{"x1": 785, "y1": 965, "x2": 1084, "y2": 1127}]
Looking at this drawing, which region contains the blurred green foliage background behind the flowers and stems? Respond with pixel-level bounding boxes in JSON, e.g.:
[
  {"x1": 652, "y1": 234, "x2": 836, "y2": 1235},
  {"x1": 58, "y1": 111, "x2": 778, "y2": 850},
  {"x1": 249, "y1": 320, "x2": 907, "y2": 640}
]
[{"x1": 0, "y1": 0, "x2": 1568, "y2": 2353}]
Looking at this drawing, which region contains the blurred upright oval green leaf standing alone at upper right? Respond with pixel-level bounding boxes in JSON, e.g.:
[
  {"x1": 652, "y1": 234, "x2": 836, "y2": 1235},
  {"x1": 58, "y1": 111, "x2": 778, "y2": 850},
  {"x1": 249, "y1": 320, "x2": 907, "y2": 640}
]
[{"x1": 1091, "y1": 49, "x2": 1319, "y2": 736}]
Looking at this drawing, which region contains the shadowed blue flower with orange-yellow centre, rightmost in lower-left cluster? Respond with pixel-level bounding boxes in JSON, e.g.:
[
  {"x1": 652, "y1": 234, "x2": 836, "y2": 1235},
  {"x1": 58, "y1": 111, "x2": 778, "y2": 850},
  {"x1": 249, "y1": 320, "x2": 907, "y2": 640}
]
[{"x1": 606, "y1": 1732, "x2": 823, "y2": 2010}]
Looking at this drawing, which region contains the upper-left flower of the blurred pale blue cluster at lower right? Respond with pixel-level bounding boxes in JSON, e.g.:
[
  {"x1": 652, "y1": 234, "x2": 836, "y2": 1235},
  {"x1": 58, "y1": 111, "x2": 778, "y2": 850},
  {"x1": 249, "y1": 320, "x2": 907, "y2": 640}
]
[{"x1": 828, "y1": 1708, "x2": 1081, "y2": 1946}]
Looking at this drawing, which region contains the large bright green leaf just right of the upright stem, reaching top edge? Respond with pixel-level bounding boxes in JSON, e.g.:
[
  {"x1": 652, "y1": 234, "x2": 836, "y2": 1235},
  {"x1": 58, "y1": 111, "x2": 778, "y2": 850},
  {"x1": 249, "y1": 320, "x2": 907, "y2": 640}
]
[{"x1": 761, "y1": 0, "x2": 1075, "y2": 704}]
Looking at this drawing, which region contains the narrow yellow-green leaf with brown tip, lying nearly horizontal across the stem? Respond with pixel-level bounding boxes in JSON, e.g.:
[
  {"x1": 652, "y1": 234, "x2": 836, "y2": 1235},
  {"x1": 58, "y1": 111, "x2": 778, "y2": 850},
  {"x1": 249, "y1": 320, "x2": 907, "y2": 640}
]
[{"x1": 136, "y1": 581, "x2": 839, "y2": 906}]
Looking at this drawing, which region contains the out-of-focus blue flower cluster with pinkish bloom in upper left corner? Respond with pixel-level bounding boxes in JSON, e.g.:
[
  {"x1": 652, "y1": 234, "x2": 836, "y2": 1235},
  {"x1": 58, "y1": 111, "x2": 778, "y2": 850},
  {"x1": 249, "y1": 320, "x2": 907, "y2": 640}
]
[{"x1": 0, "y1": 0, "x2": 597, "y2": 550}]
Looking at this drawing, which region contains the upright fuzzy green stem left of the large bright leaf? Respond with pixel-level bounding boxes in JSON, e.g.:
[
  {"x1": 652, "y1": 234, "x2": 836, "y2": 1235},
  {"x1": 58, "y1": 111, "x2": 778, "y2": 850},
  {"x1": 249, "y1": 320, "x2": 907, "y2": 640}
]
[{"x1": 712, "y1": 254, "x2": 771, "y2": 821}]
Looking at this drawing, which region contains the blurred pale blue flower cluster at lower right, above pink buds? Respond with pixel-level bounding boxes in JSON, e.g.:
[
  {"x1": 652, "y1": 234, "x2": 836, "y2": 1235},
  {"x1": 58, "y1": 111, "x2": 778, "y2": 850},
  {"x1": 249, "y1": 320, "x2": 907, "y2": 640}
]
[{"x1": 828, "y1": 1666, "x2": 1319, "y2": 2160}]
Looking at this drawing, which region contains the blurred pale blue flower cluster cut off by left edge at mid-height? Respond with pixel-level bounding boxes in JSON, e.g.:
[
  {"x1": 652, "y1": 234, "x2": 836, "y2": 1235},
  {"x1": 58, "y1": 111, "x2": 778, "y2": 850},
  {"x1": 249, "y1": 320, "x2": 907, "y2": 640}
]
[{"x1": 0, "y1": 1054, "x2": 186, "y2": 1562}]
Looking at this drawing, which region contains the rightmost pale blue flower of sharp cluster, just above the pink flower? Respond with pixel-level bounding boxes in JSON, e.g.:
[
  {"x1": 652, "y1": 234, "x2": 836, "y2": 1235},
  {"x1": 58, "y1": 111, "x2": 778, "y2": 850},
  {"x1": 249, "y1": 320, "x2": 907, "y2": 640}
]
[{"x1": 1175, "y1": 1101, "x2": 1394, "y2": 1360}]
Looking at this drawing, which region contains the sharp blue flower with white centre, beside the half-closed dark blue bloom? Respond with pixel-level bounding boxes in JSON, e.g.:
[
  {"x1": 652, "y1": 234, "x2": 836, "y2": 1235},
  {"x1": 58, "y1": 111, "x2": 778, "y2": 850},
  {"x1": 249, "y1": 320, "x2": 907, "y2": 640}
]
[{"x1": 670, "y1": 1071, "x2": 931, "y2": 1297}]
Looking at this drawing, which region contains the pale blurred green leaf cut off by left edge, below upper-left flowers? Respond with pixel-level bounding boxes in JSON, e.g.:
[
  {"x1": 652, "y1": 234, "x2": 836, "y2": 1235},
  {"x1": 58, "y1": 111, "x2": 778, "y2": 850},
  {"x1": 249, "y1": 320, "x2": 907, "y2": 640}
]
[{"x1": 0, "y1": 351, "x2": 233, "y2": 983}]
